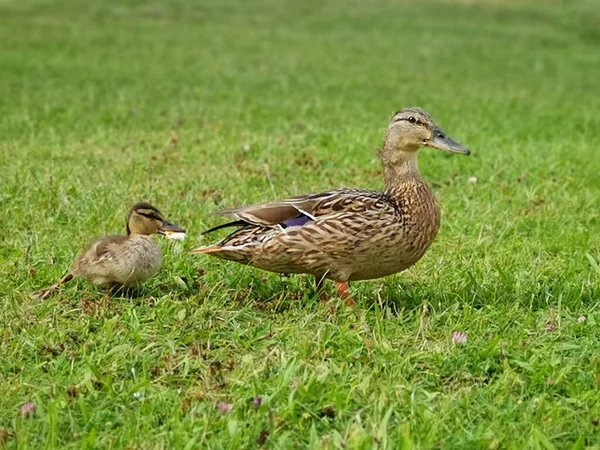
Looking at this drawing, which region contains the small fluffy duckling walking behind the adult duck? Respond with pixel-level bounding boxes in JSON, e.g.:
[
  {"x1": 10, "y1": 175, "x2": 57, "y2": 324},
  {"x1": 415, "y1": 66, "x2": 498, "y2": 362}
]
[{"x1": 34, "y1": 203, "x2": 185, "y2": 300}]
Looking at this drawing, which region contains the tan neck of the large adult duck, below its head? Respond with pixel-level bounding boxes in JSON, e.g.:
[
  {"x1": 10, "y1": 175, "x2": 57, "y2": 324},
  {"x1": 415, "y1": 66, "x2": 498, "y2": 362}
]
[{"x1": 382, "y1": 148, "x2": 423, "y2": 194}]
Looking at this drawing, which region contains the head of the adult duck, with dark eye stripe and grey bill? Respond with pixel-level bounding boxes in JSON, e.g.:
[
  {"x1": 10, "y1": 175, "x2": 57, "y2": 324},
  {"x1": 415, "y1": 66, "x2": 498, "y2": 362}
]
[{"x1": 385, "y1": 108, "x2": 471, "y2": 155}]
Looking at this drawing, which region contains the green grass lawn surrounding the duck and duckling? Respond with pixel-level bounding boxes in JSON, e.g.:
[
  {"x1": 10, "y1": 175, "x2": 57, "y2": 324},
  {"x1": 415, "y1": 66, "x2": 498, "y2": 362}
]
[{"x1": 0, "y1": 0, "x2": 600, "y2": 449}]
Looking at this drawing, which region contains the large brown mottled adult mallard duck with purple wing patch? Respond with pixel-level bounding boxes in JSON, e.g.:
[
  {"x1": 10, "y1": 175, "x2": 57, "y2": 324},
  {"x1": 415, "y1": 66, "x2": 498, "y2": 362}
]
[{"x1": 191, "y1": 108, "x2": 470, "y2": 300}]
